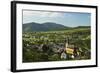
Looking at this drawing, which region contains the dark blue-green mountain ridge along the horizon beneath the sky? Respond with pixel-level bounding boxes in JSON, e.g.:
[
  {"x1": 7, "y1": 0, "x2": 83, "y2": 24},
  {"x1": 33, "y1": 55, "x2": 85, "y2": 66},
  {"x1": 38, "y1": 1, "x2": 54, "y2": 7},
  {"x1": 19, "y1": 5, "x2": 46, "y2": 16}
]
[{"x1": 23, "y1": 22, "x2": 90, "y2": 32}]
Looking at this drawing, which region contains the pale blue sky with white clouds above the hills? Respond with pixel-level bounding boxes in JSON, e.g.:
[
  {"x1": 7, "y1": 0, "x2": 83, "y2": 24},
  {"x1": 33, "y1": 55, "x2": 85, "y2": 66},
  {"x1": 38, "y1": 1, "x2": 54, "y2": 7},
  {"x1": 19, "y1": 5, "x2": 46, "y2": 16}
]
[{"x1": 23, "y1": 10, "x2": 91, "y2": 27}]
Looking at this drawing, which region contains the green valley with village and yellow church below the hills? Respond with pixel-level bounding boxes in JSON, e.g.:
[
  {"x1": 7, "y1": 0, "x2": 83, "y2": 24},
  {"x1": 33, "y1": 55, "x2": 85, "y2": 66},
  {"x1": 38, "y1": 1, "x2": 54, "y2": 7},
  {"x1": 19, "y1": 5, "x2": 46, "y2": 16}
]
[{"x1": 22, "y1": 28, "x2": 91, "y2": 62}]
